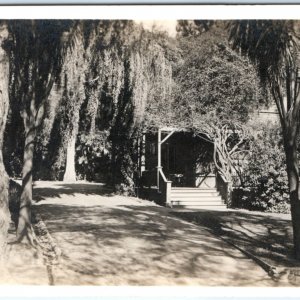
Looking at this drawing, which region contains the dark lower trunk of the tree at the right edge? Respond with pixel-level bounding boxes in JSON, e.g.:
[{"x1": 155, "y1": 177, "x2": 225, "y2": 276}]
[{"x1": 285, "y1": 141, "x2": 300, "y2": 260}]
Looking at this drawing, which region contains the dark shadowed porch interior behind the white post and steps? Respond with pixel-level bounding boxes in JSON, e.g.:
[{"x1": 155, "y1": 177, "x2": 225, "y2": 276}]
[{"x1": 142, "y1": 131, "x2": 214, "y2": 187}]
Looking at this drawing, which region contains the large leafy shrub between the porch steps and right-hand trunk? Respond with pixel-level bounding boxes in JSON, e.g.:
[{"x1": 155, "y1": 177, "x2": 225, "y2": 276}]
[{"x1": 241, "y1": 125, "x2": 289, "y2": 213}]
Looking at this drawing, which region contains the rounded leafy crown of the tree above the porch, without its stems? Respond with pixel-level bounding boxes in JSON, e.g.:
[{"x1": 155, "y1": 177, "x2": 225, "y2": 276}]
[{"x1": 176, "y1": 31, "x2": 260, "y2": 124}]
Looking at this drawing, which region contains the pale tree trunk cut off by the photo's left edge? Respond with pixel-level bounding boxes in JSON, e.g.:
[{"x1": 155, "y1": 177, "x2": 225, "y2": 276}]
[{"x1": 0, "y1": 24, "x2": 9, "y2": 257}]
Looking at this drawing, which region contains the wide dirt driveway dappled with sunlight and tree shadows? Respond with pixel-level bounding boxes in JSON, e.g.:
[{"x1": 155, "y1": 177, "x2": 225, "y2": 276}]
[{"x1": 29, "y1": 183, "x2": 276, "y2": 286}]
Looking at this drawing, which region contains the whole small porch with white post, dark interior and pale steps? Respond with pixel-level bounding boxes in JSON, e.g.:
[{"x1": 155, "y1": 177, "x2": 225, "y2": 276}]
[{"x1": 140, "y1": 127, "x2": 232, "y2": 208}]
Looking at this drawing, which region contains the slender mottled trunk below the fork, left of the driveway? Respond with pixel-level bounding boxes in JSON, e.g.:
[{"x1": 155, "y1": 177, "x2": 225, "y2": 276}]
[{"x1": 17, "y1": 118, "x2": 36, "y2": 242}]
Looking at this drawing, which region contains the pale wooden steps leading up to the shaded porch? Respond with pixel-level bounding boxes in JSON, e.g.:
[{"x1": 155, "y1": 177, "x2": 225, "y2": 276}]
[{"x1": 171, "y1": 187, "x2": 226, "y2": 209}]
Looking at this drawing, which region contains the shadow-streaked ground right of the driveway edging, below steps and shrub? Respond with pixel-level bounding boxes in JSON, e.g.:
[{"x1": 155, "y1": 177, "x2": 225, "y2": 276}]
[{"x1": 172, "y1": 211, "x2": 300, "y2": 267}]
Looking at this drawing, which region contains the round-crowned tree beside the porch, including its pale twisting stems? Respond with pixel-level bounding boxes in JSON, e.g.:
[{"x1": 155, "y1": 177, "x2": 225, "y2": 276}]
[{"x1": 174, "y1": 28, "x2": 261, "y2": 181}]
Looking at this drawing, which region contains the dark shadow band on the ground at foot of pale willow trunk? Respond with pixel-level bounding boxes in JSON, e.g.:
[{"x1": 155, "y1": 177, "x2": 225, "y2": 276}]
[{"x1": 33, "y1": 182, "x2": 113, "y2": 202}]
